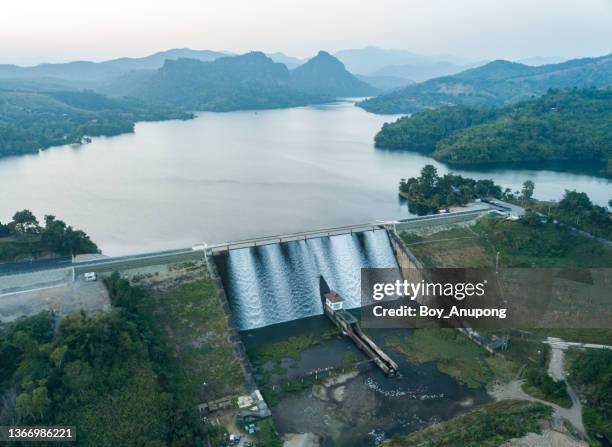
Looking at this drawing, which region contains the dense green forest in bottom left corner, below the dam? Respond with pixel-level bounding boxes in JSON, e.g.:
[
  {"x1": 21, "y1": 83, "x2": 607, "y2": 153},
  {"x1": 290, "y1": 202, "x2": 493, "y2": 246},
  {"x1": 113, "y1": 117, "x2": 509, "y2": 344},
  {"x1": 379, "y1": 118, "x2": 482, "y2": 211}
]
[{"x1": 0, "y1": 274, "x2": 204, "y2": 446}]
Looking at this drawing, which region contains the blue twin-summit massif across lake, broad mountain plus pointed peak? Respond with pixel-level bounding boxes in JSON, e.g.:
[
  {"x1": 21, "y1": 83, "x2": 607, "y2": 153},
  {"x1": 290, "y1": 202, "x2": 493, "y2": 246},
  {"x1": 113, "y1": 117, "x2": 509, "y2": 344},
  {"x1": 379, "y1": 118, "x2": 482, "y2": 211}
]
[{"x1": 138, "y1": 51, "x2": 378, "y2": 111}]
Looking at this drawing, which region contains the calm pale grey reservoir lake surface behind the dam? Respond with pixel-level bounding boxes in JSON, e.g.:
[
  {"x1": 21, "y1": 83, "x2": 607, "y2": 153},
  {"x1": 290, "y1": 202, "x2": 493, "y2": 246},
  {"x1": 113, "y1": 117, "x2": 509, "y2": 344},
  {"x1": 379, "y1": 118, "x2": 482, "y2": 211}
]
[{"x1": 0, "y1": 102, "x2": 612, "y2": 255}]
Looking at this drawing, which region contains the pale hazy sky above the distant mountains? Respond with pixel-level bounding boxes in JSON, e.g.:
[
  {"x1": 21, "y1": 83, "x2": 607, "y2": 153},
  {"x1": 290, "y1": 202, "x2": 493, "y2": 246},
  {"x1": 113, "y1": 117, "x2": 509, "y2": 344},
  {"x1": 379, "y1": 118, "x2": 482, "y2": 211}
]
[{"x1": 0, "y1": 0, "x2": 612, "y2": 64}]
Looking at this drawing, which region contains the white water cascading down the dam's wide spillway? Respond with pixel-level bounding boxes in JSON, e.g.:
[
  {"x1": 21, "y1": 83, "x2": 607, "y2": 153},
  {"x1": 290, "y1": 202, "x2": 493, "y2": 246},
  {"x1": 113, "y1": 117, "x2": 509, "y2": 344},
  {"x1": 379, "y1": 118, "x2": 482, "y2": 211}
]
[{"x1": 222, "y1": 230, "x2": 398, "y2": 330}]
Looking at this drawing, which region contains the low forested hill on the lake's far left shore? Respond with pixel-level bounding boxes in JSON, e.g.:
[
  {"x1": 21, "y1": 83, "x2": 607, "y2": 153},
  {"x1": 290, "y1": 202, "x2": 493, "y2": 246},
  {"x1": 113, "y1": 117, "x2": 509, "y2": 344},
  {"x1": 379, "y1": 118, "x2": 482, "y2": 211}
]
[{"x1": 0, "y1": 90, "x2": 192, "y2": 157}]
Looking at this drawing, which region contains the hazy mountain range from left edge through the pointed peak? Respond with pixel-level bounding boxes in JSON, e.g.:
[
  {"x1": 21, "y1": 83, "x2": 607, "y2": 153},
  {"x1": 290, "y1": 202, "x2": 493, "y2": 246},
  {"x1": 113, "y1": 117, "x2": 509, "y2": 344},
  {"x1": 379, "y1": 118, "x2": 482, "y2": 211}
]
[{"x1": 0, "y1": 49, "x2": 379, "y2": 111}]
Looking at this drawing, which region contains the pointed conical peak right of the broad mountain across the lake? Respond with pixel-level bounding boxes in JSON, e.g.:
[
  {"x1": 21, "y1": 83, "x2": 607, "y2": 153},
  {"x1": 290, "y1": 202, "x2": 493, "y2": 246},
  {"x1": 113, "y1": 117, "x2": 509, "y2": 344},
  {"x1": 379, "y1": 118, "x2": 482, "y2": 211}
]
[{"x1": 291, "y1": 51, "x2": 379, "y2": 97}]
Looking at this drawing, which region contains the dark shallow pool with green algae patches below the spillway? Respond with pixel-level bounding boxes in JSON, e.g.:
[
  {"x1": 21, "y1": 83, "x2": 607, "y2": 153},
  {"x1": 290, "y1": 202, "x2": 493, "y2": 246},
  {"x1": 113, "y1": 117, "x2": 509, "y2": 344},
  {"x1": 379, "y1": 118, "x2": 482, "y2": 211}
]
[{"x1": 241, "y1": 316, "x2": 490, "y2": 446}]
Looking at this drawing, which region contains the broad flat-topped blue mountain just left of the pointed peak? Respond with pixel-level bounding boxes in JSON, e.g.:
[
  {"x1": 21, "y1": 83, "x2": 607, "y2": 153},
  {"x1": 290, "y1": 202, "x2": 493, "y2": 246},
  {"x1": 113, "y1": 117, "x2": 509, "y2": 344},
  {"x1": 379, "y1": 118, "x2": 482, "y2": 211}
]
[{"x1": 135, "y1": 52, "x2": 328, "y2": 112}]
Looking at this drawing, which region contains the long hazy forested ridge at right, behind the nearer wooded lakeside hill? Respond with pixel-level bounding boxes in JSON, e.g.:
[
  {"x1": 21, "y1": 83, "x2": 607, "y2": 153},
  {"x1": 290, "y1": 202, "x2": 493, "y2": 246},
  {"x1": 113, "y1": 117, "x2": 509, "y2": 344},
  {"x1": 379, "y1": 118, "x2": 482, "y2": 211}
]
[{"x1": 359, "y1": 54, "x2": 612, "y2": 113}]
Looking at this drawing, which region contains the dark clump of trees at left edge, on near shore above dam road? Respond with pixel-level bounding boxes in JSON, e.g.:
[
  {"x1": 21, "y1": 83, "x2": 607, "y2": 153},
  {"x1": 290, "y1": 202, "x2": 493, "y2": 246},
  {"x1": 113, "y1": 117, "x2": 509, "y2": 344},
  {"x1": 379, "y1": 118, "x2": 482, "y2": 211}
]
[{"x1": 0, "y1": 210, "x2": 98, "y2": 262}]
